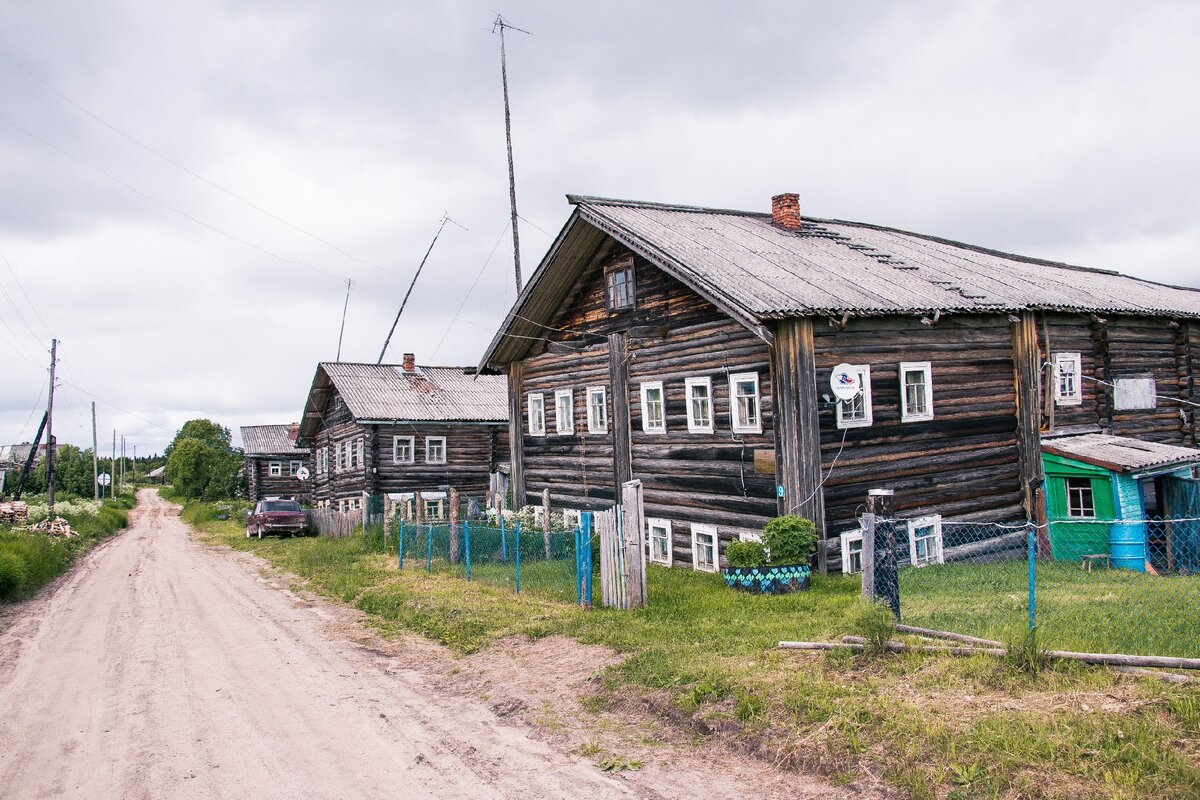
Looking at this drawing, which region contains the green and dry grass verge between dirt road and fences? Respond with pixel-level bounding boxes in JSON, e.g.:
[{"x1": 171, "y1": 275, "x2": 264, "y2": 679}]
[{"x1": 187, "y1": 496, "x2": 1200, "y2": 800}]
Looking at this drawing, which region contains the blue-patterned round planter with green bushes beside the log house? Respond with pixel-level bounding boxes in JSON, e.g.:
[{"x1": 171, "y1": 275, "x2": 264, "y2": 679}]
[{"x1": 721, "y1": 515, "x2": 817, "y2": 595}]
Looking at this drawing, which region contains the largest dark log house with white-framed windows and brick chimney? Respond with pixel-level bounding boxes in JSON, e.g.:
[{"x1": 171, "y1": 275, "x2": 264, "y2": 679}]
[{"x1": 479, "y1": 194, "x2": 1200, "y2": 570}]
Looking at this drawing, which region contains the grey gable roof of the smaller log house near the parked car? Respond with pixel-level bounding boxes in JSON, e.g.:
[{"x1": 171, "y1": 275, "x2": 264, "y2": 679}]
[{"x1": 300, "y1": 361, "x2": 509, "y2": 439}]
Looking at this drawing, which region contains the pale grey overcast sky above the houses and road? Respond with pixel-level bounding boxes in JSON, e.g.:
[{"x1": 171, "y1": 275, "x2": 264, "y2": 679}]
[{"x1": 0, "y1": 0, "x2": 1200, "y2": 453}]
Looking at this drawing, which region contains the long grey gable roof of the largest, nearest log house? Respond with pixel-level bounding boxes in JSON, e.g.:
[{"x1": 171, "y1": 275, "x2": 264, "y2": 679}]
[{"x1": 480, "y1": 196, "x2": 1200, "y2": 366}]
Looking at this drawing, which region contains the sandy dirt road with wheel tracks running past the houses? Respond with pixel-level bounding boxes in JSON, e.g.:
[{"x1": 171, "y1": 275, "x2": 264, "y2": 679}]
[{"x1": 0, "y1": 492, "x2": 690, "y2": 800}]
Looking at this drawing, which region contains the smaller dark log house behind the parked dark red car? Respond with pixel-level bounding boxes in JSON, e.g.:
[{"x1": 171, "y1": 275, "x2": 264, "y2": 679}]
[{"x1": 298, "y1": 353, "x2": 509, "y2": 513}]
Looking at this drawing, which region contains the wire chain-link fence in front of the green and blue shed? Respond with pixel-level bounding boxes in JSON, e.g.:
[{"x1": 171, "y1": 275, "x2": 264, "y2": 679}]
[{"x1": 870, "y1": 517, "x2": 1200, "y2": 657}]
